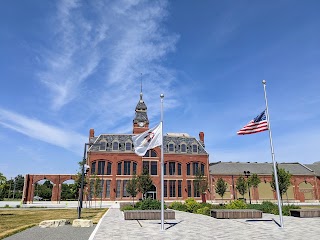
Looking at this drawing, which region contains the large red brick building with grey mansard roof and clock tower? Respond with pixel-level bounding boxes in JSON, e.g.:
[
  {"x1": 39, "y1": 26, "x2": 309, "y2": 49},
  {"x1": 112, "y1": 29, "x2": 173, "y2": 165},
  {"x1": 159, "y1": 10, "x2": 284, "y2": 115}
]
[{"x1": 87, "y1": 93, "x2": 209, "y2": 201}]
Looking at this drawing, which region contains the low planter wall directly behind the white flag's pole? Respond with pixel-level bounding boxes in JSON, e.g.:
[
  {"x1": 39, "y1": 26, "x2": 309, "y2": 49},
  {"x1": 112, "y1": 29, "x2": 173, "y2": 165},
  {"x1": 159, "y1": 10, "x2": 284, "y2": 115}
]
[{"x1": 123, "y1": 210, "x2": 175, "y2": 220}]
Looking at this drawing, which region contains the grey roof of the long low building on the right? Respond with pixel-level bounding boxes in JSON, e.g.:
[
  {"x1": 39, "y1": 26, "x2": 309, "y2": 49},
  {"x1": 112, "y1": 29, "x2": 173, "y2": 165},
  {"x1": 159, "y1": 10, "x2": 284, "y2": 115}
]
[{"x1": 209, "y1": 162, "x2": 315, "y2": 176}]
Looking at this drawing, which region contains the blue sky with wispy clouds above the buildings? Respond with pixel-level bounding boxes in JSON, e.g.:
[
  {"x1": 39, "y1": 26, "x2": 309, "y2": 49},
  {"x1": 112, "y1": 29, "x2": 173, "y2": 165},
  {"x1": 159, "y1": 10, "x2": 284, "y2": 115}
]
[{"x1": 0, "y1": 0, "x2": 320, "y2": 177}]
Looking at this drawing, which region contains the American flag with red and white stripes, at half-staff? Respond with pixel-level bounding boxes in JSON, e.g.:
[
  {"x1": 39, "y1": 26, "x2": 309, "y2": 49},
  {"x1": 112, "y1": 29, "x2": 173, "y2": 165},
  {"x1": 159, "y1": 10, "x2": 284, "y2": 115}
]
[{"x1": 237, "y1": 110, "x2": 268, "y2": 135}]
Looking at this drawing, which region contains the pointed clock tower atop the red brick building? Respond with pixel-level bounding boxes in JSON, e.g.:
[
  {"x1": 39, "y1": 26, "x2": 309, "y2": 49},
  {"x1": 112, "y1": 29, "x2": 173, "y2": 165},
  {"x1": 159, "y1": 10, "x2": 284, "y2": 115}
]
[{"x1": 133, "y1": 91, "x2": 149, "y2": 134}]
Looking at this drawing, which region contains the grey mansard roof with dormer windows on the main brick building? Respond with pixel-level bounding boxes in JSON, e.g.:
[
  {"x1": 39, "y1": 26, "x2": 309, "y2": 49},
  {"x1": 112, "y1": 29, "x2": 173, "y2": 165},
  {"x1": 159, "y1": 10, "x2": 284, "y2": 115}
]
[{"x1": 89, "y1": 134, "x2": 208, "y2": 155}]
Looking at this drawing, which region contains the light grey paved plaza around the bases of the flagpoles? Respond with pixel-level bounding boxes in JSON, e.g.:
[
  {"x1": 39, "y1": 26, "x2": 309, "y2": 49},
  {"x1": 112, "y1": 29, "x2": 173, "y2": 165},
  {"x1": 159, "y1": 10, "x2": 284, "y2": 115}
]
[{"x1": 89, "y1": 206, "x2": 320, "y2": 240}]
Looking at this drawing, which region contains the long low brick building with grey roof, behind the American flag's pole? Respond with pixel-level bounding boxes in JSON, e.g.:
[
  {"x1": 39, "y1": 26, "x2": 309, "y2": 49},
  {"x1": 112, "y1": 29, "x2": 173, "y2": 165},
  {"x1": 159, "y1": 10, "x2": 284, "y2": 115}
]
[{"x1": 209, "y1": 162, "x2": 320, "y2": 202}]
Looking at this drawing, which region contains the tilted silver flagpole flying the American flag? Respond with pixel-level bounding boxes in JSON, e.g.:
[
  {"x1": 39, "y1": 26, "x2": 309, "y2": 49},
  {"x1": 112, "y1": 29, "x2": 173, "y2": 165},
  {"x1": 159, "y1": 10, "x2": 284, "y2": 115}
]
[{"x1": 262, "y1": 80, "x2": 284, "y2": 228}]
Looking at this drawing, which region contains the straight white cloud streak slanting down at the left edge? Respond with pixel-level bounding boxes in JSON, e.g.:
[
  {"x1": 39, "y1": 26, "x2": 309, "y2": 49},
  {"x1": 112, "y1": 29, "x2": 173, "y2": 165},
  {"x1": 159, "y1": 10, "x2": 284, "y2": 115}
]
[{"x1": 0, "y1": 108, "x2": 87, "y2": 153}]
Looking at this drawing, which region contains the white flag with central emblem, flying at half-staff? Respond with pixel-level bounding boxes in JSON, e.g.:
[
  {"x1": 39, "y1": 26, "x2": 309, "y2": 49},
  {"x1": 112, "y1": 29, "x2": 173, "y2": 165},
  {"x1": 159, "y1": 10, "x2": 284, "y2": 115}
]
[{"x1": 132, "y1": 123, "x2": 162, "y2": 156}]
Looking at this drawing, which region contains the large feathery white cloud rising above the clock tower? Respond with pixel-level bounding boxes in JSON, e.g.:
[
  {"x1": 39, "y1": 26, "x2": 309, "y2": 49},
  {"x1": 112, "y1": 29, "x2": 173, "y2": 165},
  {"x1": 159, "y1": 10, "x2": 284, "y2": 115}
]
[{"x1": 38, "y1": 0, "x2": 179, "y2": 131}]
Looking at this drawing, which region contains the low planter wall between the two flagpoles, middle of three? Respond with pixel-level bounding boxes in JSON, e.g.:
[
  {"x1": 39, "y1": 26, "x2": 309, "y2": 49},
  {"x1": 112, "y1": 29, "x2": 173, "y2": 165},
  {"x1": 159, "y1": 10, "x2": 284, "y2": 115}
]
[{"x1": 211, "y1": 209, "x2": 262, "y2": 219}]
